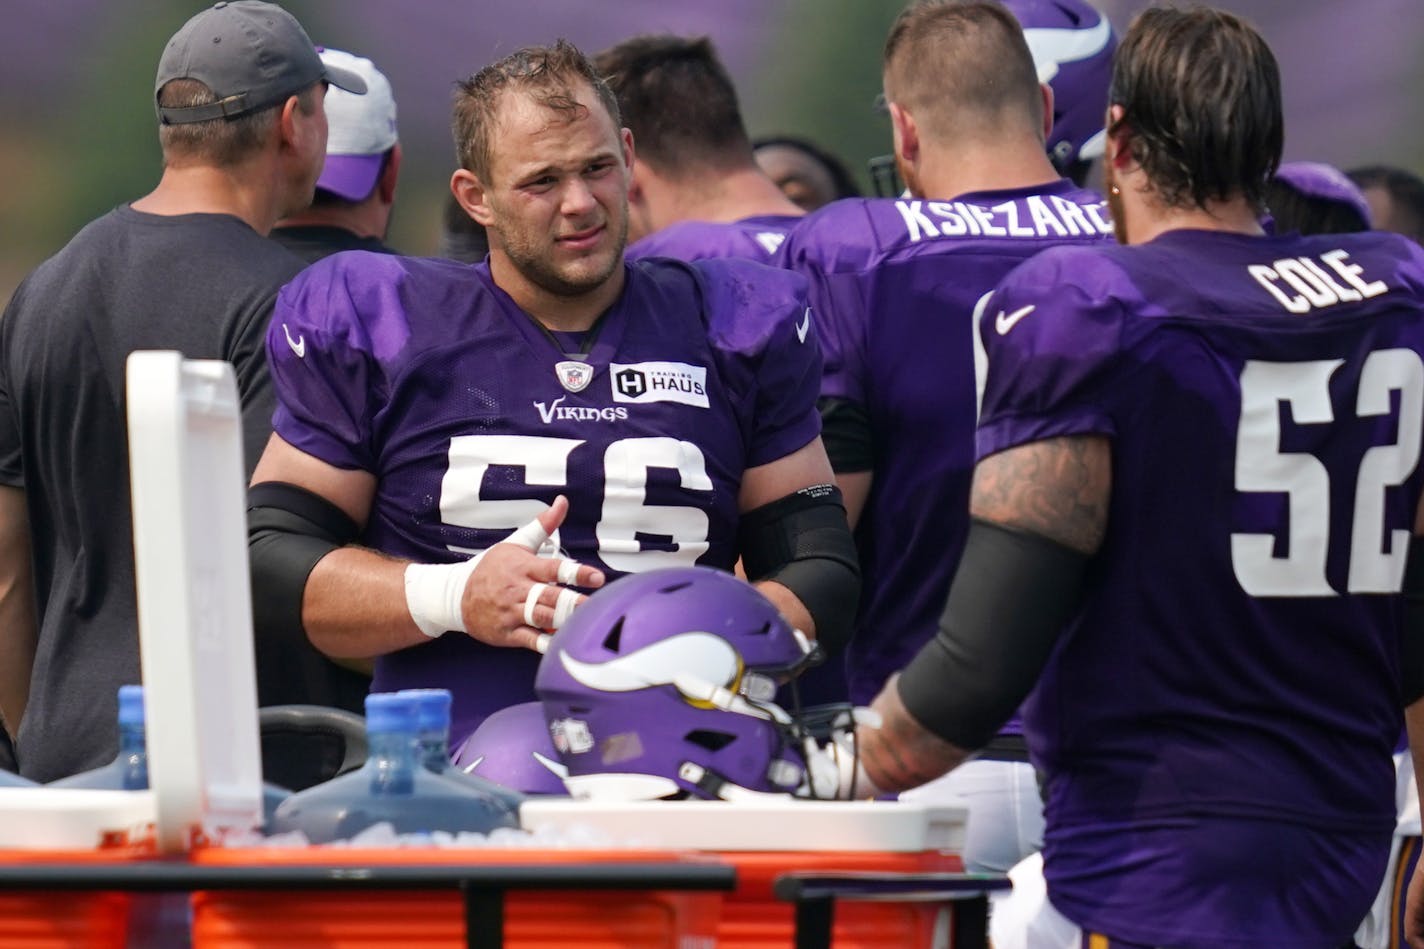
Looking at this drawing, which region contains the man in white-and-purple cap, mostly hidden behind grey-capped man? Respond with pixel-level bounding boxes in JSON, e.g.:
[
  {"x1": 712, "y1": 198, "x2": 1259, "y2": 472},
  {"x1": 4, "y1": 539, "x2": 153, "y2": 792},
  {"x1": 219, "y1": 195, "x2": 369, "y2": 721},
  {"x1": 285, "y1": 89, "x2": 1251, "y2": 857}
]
[{"x1": 272, "y1": 48, "x2": 400, "y2": 262}]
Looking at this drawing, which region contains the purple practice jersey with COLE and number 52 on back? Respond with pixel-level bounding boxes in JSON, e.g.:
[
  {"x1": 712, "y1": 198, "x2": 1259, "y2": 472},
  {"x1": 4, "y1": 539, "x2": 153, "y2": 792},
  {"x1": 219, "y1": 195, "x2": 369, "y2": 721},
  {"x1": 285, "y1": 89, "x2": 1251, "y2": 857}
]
[{"x1": 978, "y1": 229, "x2": 1424, "y2": 949}]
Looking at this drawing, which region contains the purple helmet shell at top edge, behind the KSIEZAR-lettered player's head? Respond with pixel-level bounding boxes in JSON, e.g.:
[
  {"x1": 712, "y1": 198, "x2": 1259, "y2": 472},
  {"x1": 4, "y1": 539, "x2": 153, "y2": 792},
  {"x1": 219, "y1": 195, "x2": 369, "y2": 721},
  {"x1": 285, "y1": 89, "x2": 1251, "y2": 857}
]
[{"x1": 1004, "y1": 0, "x2": 1118, "y2": 171}]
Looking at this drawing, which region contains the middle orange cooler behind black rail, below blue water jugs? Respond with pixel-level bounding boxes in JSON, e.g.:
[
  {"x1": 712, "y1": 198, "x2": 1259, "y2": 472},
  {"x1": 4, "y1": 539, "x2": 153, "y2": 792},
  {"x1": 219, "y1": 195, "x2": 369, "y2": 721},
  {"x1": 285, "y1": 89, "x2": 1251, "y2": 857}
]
[{"x1": 192, "y1": 848, "x2": 723, "y2": 949}]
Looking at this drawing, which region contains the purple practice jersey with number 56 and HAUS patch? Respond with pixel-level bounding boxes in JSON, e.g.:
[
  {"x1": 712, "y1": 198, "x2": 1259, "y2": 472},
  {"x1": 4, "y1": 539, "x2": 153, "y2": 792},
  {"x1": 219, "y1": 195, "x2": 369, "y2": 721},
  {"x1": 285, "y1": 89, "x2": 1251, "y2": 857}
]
[{"x1": 268, "y1": 254, "x2": 820, "y2": 735}]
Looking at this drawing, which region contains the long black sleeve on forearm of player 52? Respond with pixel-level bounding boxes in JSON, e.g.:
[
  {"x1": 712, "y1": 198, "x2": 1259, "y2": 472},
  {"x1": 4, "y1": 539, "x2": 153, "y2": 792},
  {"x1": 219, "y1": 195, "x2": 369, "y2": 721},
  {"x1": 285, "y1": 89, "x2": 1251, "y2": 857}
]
[{"x1": 900, "y1": 517, "x2": 1089, "y2": 751}]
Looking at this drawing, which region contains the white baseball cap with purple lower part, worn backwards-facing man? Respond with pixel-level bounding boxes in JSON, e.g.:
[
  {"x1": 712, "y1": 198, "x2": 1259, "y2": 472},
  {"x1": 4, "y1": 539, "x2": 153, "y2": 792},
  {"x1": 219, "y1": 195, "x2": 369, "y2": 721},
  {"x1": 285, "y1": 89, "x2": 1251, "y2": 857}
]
[{"x1": 316, "y1": 47, "x2": 396, "y2": 201}]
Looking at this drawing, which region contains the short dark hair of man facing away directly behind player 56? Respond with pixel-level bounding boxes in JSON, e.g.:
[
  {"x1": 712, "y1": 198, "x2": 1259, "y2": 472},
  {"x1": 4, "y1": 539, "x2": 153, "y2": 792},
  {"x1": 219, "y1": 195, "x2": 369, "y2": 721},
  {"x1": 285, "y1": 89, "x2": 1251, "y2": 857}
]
[{"x1": 594, "y1": 36, "x2": 752, "y2": 180}]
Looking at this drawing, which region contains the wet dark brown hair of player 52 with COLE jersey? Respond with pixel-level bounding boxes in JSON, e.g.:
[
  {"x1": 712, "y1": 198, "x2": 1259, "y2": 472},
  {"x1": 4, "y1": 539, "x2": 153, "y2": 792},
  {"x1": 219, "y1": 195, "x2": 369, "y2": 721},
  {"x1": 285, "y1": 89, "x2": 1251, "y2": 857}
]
[{"x1": 1108, "y1": 7, "x2": 1284, "y2": 209}]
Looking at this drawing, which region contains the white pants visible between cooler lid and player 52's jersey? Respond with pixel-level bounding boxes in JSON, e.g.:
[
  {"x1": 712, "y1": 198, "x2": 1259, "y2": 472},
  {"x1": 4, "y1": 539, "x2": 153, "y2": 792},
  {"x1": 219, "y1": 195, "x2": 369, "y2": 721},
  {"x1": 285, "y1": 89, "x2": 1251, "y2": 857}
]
[{"x1": 900, "y1": 759, "x2": 1044, "y2": 873}]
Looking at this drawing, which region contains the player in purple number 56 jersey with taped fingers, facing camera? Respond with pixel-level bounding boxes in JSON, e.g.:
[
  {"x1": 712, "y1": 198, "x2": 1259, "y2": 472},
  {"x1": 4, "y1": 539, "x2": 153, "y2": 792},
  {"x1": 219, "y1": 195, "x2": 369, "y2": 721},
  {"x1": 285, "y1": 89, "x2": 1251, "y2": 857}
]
[{"x1": 249, "y1": 41, "x2": 859, "y2": 734}]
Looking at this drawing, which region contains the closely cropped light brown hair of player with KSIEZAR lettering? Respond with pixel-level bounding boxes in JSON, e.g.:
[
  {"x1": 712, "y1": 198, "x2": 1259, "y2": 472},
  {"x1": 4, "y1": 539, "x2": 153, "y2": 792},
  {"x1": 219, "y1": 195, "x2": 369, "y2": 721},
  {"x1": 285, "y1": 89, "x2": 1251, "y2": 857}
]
[{"x1": 881, "y1": 0, "x2": 1044, "y2": 141}]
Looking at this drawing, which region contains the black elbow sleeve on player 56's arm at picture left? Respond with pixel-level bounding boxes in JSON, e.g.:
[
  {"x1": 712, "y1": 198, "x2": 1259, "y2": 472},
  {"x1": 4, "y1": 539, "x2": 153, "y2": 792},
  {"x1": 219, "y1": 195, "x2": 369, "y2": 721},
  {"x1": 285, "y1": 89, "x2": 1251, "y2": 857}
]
[{"x1": 248, "y1": 482, "x2": 360, "y2": 637}]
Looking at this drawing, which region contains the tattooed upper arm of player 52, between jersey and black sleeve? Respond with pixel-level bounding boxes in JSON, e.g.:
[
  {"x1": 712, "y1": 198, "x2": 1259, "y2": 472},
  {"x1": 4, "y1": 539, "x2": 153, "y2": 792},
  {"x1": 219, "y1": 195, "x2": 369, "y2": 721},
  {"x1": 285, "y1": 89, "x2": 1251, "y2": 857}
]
[{"x1": 970, "y1": 435, "x2": 1112, "y2": 554}]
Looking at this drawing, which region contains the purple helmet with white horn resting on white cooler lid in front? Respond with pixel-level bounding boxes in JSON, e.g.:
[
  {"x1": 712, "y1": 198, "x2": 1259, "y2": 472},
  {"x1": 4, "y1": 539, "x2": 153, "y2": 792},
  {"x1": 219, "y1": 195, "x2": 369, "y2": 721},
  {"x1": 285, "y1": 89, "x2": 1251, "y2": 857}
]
[{"x1": 534, "y1": 567, "x2": 819, "y2": 801}]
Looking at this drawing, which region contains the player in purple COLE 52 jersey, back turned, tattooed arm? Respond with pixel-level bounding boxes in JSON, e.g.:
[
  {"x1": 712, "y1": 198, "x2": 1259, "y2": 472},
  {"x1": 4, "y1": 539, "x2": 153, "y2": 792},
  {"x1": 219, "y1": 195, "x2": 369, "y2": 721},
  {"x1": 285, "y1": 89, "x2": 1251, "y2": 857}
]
[{"x1": 837, "y1": 7, "x2": 1424, "y2": 949}]
